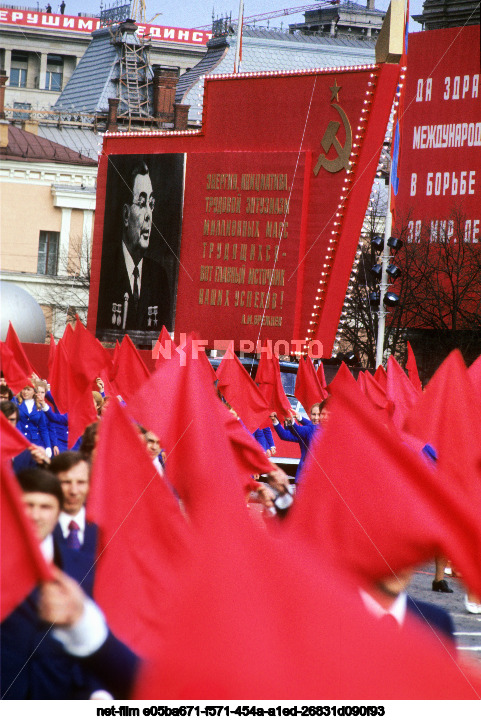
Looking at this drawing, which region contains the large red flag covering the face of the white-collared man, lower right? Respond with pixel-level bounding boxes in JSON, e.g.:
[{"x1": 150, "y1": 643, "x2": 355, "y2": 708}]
[{"x1": 287, "y1": 372, "x2": 481, "y2": 592}]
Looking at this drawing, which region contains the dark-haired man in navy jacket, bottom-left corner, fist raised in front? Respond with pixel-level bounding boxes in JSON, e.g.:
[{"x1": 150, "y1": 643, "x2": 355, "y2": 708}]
[{"x1": 0, "y1": 469, "x2": 137, "y2": 700}]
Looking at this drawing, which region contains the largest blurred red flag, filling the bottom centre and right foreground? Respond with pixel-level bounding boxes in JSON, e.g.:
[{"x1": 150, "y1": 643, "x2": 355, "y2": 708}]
[{"x1": 135, "y1": 382, "x2": 480, "y2": 700}]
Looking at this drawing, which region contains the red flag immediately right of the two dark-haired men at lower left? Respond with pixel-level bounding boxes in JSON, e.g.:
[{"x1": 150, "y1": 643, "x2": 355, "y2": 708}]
[{"x1": 87, "y1": 398, "x2": 189, "y2": 656}]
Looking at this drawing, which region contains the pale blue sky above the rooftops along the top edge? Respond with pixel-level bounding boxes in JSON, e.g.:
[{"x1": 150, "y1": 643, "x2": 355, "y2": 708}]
[{"x1": 51, "y1": 0, "x2": 423, "y2": 31}]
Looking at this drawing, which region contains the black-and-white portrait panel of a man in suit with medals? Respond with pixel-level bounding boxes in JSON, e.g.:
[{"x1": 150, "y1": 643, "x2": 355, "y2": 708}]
[{"x1": 97, "y1": 153, "x2": 183, "y2": 344}]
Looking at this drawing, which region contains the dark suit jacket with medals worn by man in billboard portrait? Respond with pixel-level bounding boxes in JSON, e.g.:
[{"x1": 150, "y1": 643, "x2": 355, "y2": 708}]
[{"x1": 97, "y1": 250, "x2": 172, "y2": 331}]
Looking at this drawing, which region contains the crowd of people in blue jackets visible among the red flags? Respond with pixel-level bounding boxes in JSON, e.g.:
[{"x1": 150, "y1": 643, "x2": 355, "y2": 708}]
[{"x1": 0, "y1": 334, "x2": 481, "y2": 700}]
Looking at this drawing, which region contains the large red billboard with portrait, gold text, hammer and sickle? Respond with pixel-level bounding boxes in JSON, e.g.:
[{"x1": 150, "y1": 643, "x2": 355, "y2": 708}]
[{"x1": 89, "y1": 65, "x2": 399, "y2": 356}]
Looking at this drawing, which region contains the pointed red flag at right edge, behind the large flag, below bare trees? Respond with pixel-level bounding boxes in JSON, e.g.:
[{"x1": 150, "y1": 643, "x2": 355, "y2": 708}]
[{"x1": 404, "y1": 350, "x2": 481, "y2": 492}]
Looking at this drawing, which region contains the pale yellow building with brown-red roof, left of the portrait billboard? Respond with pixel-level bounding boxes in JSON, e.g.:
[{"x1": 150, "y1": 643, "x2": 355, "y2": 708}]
[{"x1": 0, "y1": 120, "x2": 97, "y2": 338}]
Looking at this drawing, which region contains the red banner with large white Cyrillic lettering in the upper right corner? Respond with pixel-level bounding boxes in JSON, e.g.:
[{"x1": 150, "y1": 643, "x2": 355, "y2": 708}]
[{"x1": 396, "y1": 25, "x2": 481, "y2": 243}]
